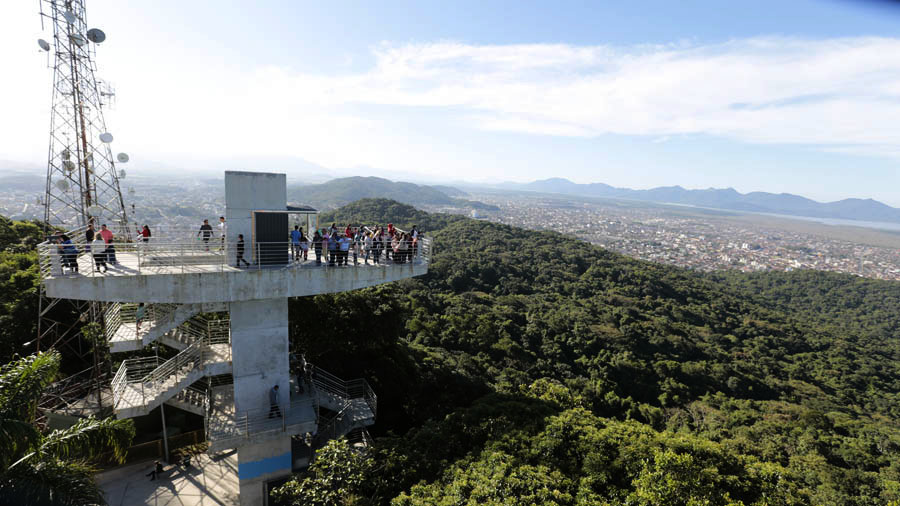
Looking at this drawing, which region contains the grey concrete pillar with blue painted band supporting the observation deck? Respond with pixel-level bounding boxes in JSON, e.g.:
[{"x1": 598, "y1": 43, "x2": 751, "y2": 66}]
[{"x1": 230, "y1": 298, "x2": 291, "y2": 506}]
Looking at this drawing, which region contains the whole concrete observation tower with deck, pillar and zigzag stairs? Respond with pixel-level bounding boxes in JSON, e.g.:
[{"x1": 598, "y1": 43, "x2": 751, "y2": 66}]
[{"x1": 38, "y1": 172, "x2": 431, "y2": 505}]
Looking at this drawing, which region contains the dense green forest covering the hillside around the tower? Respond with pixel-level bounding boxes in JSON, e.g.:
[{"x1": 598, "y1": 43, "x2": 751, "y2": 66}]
[{"x1": 0, "y1": 203, "x2": 900, "y2": 506}]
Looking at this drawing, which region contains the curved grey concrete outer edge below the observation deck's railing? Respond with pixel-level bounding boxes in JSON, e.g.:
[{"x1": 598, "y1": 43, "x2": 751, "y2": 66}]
[{"x1": 44, "y1": 264, "x2": 428, "y2": 304}]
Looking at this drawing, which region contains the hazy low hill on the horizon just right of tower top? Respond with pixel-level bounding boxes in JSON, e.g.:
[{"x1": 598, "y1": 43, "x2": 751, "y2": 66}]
[{"x1": 288, "y1": 177, "x2": 498, "y2": 210}]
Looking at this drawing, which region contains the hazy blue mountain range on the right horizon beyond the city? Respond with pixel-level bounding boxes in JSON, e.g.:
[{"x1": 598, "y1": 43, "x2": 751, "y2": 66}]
[{"x1": 502, "y1": 178, "x2": 900, "y2": 223}]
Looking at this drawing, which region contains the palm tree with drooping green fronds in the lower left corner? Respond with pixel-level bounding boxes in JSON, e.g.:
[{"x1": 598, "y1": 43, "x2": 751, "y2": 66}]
[{"x1": 0, "y1": 351, "x2": 134, "y2": 505}]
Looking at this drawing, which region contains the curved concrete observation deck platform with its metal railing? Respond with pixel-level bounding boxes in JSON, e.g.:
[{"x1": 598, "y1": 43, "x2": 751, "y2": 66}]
[{"x1": 38, "y1": 237, "x2": 431, "y2": 304}]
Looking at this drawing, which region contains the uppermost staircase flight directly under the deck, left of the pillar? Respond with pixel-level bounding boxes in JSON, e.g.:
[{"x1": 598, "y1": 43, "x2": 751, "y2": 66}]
[{"x1": 103, "y1": 303, "x2": 225, "y2": 353}]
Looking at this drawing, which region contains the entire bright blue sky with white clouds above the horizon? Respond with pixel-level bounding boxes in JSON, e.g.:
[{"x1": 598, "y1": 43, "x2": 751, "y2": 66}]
[{"x1": 0, "y1": 0, "x2": 900, "y2": 206}]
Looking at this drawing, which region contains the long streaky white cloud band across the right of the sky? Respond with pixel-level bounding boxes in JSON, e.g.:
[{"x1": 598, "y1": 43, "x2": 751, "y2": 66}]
[{"x1": 268, "y1": 37, "x2": 900, "y2": 154}]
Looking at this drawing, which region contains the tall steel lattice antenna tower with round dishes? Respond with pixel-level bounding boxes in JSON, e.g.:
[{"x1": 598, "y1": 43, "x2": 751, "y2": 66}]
[{"x1": 36, "y1": 0, "x2": 131, "y2": 374}]
